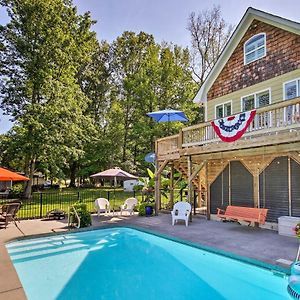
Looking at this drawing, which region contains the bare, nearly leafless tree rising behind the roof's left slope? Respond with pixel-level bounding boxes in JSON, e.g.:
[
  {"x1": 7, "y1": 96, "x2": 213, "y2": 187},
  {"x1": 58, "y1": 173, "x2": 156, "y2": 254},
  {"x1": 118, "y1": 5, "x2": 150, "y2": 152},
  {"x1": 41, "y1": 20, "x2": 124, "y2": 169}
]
[{"x1": 188, "y1": 6, "x2": 233, "y2": 85}]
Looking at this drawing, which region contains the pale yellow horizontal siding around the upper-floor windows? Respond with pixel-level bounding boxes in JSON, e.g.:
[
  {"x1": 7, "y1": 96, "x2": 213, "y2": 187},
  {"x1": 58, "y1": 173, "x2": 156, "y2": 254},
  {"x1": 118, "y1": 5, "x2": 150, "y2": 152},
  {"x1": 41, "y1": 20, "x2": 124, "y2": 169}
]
[{"x1": 207, "y1": 69, "x2": 300, "y2": 120}]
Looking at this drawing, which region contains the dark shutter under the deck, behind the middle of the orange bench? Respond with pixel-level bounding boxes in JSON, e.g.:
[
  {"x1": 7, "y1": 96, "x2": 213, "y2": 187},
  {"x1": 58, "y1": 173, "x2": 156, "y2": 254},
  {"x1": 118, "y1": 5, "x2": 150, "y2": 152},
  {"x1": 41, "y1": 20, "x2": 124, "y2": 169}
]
[{"x1": 230, "y1": 161, "x2": 254, "y2": 207}]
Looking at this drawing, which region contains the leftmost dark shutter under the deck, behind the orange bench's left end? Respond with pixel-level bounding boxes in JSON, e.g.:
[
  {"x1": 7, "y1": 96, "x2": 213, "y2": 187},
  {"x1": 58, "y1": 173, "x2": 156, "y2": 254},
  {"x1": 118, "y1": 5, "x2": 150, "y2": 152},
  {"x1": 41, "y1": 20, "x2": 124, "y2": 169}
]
[{"x1": 210, "y1": 166, "x2": 229, "y2": 214}]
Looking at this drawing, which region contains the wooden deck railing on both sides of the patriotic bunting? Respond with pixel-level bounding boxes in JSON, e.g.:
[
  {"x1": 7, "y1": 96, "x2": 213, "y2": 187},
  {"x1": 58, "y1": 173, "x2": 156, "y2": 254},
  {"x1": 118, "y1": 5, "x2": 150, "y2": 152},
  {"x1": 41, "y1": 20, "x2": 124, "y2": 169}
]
[{"x1": 157, "y1": 97, "x2": 300, "y2": 156}]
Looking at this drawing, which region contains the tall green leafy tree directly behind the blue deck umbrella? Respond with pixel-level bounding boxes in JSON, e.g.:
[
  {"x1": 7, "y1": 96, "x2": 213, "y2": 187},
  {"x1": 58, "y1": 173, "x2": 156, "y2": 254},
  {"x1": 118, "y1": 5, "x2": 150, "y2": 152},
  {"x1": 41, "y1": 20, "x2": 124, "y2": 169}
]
[{"x1": 104, "y1": 32, "x2": 195, "y2": 171}]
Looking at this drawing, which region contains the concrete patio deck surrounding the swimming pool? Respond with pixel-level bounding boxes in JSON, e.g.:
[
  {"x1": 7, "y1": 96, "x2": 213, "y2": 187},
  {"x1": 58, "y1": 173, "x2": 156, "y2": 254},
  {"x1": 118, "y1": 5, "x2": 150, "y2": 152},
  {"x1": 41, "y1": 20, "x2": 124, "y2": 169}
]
[{"x1": 0, "y1": 214, "x2": 299, "y2": 300}]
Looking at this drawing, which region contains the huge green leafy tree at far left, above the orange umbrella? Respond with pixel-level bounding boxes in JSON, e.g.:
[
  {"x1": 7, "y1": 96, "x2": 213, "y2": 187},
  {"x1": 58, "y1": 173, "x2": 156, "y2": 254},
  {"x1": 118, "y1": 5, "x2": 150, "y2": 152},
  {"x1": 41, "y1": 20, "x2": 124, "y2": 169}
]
[{"x1": 0, "y1": 0, "x2": 96, "y2": 197}]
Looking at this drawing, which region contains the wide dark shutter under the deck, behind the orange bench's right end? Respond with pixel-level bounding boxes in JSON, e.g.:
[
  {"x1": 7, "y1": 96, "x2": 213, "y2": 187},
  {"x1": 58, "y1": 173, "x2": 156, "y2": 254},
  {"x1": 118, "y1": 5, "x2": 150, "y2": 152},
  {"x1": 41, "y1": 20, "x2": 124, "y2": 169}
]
[{"x1": 259, "y1": 157, "x2": 289, "y2": 222}]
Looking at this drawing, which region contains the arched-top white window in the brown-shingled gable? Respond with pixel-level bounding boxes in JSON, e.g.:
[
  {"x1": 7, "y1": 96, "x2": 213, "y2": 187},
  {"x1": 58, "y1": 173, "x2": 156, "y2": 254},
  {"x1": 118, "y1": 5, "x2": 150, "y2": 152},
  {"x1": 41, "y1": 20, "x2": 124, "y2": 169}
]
[{"x1": 244, "y1": 33, "x2": 266, "y2": 65}]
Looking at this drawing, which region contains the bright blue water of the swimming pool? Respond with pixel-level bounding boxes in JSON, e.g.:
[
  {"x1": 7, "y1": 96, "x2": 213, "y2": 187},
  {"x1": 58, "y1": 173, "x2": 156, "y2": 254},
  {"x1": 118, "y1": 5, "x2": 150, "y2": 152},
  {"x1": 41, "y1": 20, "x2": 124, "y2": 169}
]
[{"x1": 6, "y1": 228, "x2": 289, "y2": 300}]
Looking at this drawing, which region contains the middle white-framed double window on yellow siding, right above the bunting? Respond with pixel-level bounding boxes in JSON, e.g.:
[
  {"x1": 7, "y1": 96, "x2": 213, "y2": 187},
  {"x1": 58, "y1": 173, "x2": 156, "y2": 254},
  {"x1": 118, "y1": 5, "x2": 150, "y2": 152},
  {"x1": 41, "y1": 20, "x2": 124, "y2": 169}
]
[{"x1": 241, "y1": 89, "x2": 271, "y2": 111}]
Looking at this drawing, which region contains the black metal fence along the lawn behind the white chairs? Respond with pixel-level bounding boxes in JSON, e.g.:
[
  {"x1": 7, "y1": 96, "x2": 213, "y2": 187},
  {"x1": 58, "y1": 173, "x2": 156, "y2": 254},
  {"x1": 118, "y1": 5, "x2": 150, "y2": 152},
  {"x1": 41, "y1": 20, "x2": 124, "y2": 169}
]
[{"x1": 0, "y1": 190, "x2": 142, "y2": 219}]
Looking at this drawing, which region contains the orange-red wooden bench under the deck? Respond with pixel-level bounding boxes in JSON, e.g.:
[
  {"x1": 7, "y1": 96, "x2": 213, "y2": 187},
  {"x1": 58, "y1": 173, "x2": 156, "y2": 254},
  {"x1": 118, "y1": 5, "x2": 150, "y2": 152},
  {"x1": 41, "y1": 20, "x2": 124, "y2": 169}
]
[{"x1": 217, "y1": 205, "x2": 268, "y2": 225}]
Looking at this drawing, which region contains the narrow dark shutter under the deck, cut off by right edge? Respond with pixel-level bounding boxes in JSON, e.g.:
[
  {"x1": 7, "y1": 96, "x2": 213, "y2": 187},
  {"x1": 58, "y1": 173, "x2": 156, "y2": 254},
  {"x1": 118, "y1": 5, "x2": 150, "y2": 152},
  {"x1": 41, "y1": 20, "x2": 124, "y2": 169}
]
[{"x1": 291, "y1": 159, "x2": 300, "y2": 217}]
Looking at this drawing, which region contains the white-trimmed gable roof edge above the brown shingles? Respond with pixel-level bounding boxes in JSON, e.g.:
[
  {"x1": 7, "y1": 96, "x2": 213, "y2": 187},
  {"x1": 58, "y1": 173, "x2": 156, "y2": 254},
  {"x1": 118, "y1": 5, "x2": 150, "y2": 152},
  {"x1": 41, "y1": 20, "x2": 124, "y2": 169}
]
[{"x1": 194, "y1": 7, "x2": 300, "y2": 103}]
